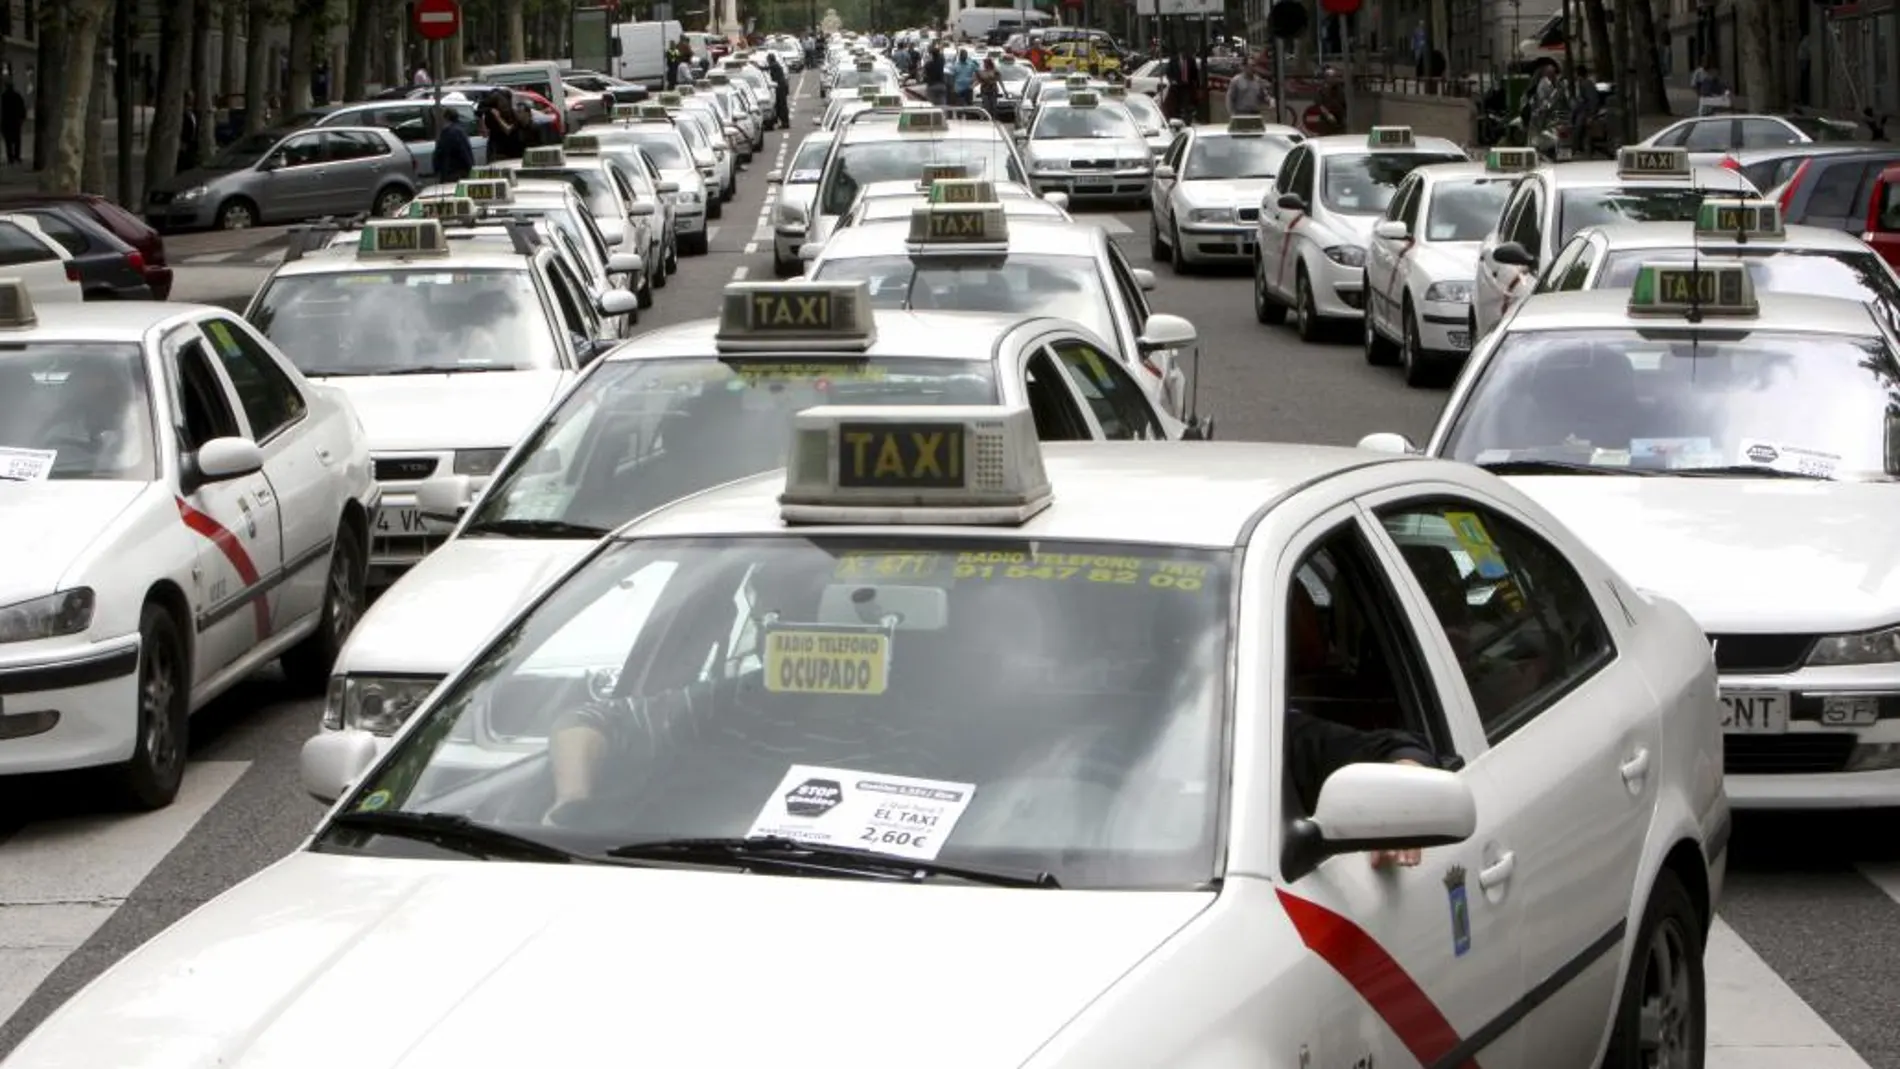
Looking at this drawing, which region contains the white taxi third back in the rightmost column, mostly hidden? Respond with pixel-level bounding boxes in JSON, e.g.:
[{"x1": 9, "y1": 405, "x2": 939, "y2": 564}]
[{"x1": 1471, "y1": 146, "x2": 1759, "y2": 336}]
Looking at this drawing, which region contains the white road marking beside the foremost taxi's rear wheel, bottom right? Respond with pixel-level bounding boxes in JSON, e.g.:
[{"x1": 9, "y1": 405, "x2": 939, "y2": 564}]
[{"x1": 1702, "y1": 917, "x2": 1870, "y2": 1069}]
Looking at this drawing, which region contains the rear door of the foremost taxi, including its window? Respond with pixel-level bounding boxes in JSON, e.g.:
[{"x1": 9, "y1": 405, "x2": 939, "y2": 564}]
[{"x1": 1366, "y1": 488, "x2": 1663, "y2": 1069}]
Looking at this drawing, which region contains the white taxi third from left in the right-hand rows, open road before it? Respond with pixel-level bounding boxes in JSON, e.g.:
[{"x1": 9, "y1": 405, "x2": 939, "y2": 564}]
[{"x1": 1254, "y1": 125, "x2": 1465, "y2": 342}]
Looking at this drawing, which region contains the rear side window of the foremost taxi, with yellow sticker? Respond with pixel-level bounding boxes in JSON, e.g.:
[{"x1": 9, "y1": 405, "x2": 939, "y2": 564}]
[{"x1": 1379, "y1": 501, "x2": 1615, "y2": 744}]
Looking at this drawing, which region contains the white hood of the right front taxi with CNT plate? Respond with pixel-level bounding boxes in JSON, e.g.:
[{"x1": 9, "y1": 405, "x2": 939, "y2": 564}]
[{"x1": 1511, "y1": 475, "x2": 1900, "y2": 632}]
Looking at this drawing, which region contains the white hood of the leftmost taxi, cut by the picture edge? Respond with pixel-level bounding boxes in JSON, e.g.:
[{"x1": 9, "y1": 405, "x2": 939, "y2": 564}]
[{"x1": 0, "y1": 478, "x2": 150, "y2": 606}]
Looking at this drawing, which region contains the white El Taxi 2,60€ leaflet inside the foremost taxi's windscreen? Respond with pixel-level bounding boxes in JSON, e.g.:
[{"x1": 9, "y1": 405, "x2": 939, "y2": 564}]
[{"x1": 747, "y1": 765, "x2": 977, "y2": 860}]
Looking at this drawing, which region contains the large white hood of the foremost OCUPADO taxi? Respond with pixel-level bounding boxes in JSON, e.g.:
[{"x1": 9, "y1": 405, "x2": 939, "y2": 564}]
[{"x1": 8, "y1": 853, "x2": 1214, "y2": 1069}]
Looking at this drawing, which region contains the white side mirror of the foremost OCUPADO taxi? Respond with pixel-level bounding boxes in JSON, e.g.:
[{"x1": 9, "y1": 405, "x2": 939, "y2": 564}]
[{"x1": 1281, "y1": 763, "x2": 1478, "y2": 881}]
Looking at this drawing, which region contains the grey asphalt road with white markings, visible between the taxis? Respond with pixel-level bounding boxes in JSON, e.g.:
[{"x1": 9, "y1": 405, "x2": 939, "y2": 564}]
[{"x1": 0, "y1": 71, "x2": 1900, "y2": 1069}]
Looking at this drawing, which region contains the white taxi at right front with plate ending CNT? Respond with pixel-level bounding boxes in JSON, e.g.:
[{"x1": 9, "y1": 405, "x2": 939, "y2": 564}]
[{"x1": 1362, "y1": 256, "x2": 1900, "y2": 809}]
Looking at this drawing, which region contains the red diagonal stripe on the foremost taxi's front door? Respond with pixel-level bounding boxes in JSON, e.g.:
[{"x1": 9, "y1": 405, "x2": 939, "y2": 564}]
[{"x1": 1277, "y1": 891, "x2": 1478, "y2": 1069}]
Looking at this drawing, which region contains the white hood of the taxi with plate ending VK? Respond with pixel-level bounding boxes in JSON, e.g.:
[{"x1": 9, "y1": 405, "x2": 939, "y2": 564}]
[{"x1": 315, "y1": 368, "x2": 568, "y2": 452}]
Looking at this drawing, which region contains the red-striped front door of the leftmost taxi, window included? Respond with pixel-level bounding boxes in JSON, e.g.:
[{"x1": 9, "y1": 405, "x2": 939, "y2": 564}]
[{"x1": 160, "y1": 323, "x2": 283, "y2": 684}]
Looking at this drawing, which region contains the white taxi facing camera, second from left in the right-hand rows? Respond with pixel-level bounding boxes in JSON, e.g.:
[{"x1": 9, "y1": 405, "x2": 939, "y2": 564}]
[{"x1": 1148, "y1": 116, "x2": 1305, "y2": 275}]
